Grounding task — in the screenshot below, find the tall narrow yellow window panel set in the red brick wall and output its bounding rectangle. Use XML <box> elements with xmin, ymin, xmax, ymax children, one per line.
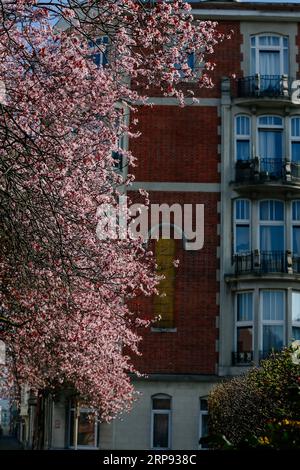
<box><xmin>154</xmin><ymin>238</ymin><xmax>176</xmax><ymax>329</ymax></box>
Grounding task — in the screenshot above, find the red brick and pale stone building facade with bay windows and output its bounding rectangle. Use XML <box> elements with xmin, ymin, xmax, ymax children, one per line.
<box><xmin>18</xmin><ymin>1</ymin><xmax>300</xmax><ymax>450</ymax></box>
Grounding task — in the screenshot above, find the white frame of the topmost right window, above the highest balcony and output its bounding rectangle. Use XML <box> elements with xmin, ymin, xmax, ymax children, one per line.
<box><xmin>250</xmin><ymin>33</ymin><xmax>290</xmax><ymax>75</ymax></box>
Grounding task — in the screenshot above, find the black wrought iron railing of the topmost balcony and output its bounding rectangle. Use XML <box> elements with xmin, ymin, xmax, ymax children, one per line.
<box><xmin>238</xmin><ymin>73</ymin><xmax>291</xmax><ymax>98</ymax></box>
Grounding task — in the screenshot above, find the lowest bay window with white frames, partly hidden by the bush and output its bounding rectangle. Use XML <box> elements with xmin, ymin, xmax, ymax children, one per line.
<box><xmin>232</xmin><ymin>287</ymin><xmax>300</xmax><ymax>366</ymax></box>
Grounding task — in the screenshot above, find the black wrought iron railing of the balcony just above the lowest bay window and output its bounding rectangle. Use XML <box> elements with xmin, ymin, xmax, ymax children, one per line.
<box><xmin>233</xmin><ymin>250</ymin><xmax>300</xmax><ymax>275</ymax></box>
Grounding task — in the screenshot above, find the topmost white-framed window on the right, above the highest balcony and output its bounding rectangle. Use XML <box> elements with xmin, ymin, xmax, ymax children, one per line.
<box><xmin>250</xmin><ymin>34</ymin><xmax>289</xmax><ymax>77</ymax></box>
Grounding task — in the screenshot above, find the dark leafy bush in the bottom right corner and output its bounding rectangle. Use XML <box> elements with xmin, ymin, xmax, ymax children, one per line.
<box><xmin>208</xmin><ymin>341</ymin><xmax>300</xmax><ymax>448</ymax></box>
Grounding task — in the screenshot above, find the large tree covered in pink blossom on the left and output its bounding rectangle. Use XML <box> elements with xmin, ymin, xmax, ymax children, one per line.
<box><xmin>0</xmin><ymin>0</ymin><xmax>223</xmax><ymax>419</ymax></box>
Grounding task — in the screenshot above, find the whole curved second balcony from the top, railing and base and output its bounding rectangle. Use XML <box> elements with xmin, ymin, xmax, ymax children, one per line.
<box><xmin>235</xmin><ymin>157</ymin><xmax>300</xmax><ymax>191</ymax></box>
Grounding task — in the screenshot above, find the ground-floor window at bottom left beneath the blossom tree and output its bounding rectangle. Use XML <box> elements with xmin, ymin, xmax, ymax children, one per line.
<box><xmin>69</xmin><ymin>404</ymin><xmax>98</xmax><ymax>448</ymax></box>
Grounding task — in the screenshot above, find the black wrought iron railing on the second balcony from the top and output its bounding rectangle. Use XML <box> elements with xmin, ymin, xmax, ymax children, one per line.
<box><xmin>235</xmin><ymin>157</ymin><xmax>300</xmax><ymax>184</ymax></box>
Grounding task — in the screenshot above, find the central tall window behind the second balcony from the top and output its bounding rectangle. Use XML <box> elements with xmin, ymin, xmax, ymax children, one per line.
<box><xmin>258</xmin><ymin>116</ymin><xmax>283</xmax><ymax>178</ymax></box>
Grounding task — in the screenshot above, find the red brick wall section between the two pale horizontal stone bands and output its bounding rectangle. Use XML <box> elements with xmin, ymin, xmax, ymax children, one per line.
<box><xmin>130</xmin><ymin>106</ymin><xmax>220</xmax><ymax>183</ymax></box>
